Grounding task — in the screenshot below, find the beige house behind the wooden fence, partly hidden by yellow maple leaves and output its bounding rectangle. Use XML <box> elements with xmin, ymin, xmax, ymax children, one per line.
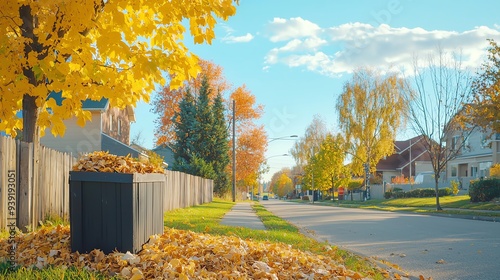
<box><xmin>40</xmin><ymin>93</ymin><xmax>140</xmax><ymax>157</ymax></box>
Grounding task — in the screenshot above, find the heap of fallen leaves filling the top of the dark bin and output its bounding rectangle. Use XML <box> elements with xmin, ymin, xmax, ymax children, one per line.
<box><xmin>73</xmin><ymin>151</ymin><xmax>165</xmax><ymax>174</ymax></box>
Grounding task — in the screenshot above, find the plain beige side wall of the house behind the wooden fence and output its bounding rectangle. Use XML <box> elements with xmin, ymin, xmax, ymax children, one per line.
<box><xmin>40</xmin><ymin>111</ymin><xmax>102</xmax><ymax>157</ymax></box>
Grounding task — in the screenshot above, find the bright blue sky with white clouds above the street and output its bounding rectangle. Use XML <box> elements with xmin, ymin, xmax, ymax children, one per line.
<box><xmin>131</xmin><ymin>0</ymin><xmax>500</xmax><ymax>179</ymax></box>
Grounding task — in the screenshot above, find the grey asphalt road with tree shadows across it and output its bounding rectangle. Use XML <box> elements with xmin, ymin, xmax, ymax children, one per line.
<box><xmin>261</xmin><ymin>199</ymin><xmax>500</xmax><ymax>280</ymax></box>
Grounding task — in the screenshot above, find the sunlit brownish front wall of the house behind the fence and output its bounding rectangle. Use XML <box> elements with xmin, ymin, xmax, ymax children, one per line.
<box><xmin>102</xmin><ymin>107</ymin><xmax>130</xmax><ymax>145</ymax></box>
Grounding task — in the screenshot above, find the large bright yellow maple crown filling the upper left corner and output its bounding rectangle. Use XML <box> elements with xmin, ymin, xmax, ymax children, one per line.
<box><xmin>0</xmin><ymin>0</ymin><xmax>238</xmax><ymax>142</ymax></box>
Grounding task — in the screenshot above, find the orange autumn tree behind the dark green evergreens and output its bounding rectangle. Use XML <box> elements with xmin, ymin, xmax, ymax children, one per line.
<box><xmin>153</xmin><ymin>59</ymin><xmax>267</xmax><ymax>190</ymax></box>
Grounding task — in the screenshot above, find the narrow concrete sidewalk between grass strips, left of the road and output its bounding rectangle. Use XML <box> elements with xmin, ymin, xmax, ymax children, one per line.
<box><xmin>220</xmin><ymin>202</ymin><xmax>266</xmax><ymax>230</ymax></box>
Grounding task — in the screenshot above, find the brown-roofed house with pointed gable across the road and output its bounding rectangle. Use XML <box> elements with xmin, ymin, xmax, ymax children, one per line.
<box><xmin>376</xmin><ymin>136</ymin><xmax>432</xmax><ymax>183</ymax></box>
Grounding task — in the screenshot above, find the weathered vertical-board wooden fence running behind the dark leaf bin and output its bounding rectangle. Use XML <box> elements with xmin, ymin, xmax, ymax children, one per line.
<box><xmin>0</xmin><ymin>136</ymin><xmax>213</xmax><ymax>230</ymax></box>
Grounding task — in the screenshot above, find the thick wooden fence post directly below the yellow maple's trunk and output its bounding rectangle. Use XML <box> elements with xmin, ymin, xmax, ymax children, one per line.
<box><xmin>16</xmin><ymin>141</ymin><xmax>33</xmax><ymax>231</ymax></box>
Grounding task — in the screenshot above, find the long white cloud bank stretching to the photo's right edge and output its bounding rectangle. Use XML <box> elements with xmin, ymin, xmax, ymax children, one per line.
<box><xmin>265</xmin><ymin>18</ymin><xmax>500</xmax><ymax>76</ymax></box>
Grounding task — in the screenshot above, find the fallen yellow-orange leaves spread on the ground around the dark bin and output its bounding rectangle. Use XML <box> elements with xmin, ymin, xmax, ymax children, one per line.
<box><xmin>0</xmin><ymin>226</ymin><xmax>372</xmax><ymax>279</ymax></box>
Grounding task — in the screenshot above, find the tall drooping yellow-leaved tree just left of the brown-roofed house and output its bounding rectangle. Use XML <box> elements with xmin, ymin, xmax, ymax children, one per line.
<box><xmin>337</xmin><ymin>69</ymin><xmax>406</xmax><ymax>199</ymax></box>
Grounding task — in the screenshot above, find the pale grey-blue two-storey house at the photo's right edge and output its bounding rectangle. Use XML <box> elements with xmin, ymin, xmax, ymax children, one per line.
<box><xmin>446</xmin><ymin>128</ymin><xmax>500</xmax><ymax>188</ymax></box>
